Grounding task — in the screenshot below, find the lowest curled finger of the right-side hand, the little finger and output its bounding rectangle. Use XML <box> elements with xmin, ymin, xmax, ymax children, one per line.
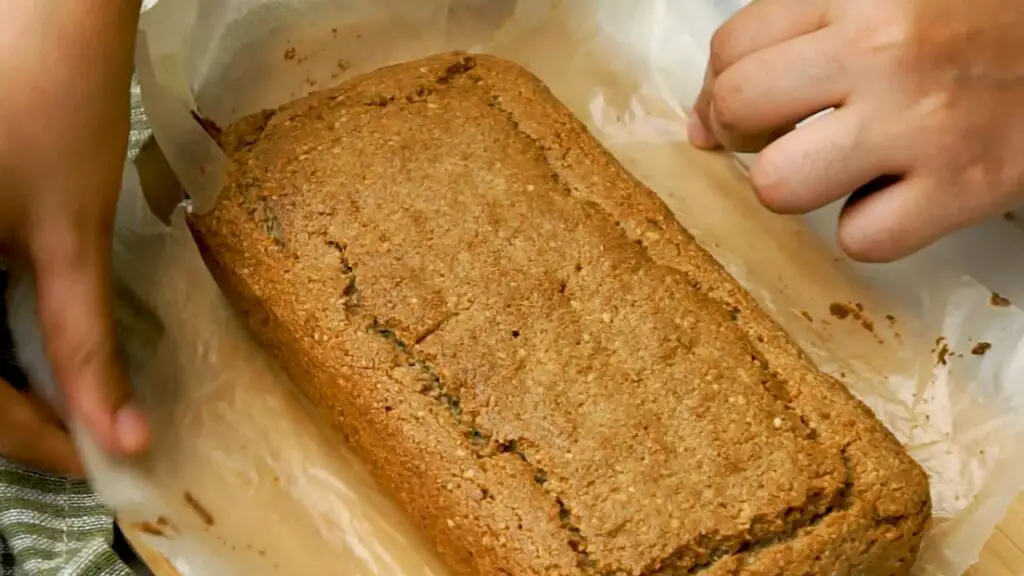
<box><xmin>839</xmin><ymin>177</ymin><xmax>998</xmax><ymax>262</ymax></box>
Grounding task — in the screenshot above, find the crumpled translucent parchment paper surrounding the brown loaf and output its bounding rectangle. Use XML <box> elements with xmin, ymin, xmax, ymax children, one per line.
<box><xmin>19</xmin><ymin>0</ymin><xmax>1024</xmax><ymax>576</ymax></box>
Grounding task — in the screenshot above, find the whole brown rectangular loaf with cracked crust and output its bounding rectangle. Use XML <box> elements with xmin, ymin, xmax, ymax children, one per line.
<box><xmin>191</xmin><ymin>53</ymin><xmax>930</xmax><ymax>576</ymax></box>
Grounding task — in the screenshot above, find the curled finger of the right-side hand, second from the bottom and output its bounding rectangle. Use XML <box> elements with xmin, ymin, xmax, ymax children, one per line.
<box><xmin>750</xmin><ymin>106</ymin><xmax>909</xmax><ymax>214</ymax></box>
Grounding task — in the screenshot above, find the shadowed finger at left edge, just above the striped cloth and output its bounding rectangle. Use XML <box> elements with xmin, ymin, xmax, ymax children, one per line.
<box><xmin>0</xmin><ymin>381</ymin><xmax>83</xmax><ymax>477</ymax></box>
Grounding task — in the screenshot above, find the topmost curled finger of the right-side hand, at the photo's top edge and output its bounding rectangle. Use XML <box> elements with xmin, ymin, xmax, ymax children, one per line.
<box><xmin>710</xmin><ymin>0</ymin><xmax>828</xmax><ymax>77</ymax></box>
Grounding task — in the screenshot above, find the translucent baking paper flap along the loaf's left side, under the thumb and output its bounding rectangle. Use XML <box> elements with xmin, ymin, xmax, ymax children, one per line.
<box><xmin>7</xmin><ymin>157</ymin><xmax>445</xmax><ymax>576</ymax></box>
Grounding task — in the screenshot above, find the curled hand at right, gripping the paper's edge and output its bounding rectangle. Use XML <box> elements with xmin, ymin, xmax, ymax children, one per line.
<box><xmin>689</xmin><ymin>0</ymin><xmax>1024</xmax><ymax>261</ymax></box>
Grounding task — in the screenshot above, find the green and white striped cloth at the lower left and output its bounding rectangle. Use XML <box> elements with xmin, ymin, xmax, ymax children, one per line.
<box><xmin>0</xmin><ymin>76</ymin><xmax>150</xmax><ymax>576</ymax></box>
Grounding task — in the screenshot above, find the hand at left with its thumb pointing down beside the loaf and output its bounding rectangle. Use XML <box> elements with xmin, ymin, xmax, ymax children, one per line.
<box><xmin>0</xmin><ymin>0</ymin><xmax>148</xmax><ymax>461</ymax></box>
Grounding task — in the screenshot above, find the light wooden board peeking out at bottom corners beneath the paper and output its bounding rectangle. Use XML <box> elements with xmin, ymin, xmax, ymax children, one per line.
<box><xmin>122</xmin><ymin>496</ymin><xmax>1024</xmax><ymax>576</ymax></box>
